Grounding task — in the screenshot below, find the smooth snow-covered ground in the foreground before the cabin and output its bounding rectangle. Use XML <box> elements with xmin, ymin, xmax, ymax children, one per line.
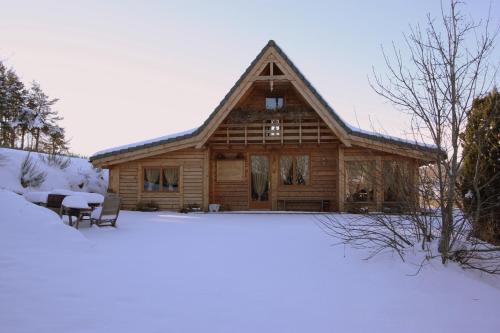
<box><xmin>0</xmin><ymin>191</ymin><xmax>500</xmax><ymax>333</ymax></box>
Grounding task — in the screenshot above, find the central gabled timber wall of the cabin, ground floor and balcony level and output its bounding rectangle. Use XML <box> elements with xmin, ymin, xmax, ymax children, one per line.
<box><xmin>208</xmin><ymin>82</ymin><xmax>339</xmax><ymax>211</ymax></box>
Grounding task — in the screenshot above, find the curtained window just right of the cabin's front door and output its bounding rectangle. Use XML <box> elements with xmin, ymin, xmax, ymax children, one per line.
<box><xmin>280</xmin><ymin>155</ymin><xmax>310</xmax><ymax>185</ymax></box>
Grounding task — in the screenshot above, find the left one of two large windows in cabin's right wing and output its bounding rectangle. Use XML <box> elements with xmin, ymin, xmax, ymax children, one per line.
<box><xmin>344</xmin><ymin>161</ymin><xmax>375</xmax><ymax>202</ymax></box>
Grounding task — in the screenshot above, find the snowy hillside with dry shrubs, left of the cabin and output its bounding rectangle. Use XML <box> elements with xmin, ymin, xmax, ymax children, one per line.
<box><xmin>0</xmin><ymin>148</ymin><xmax>108</xmax><ymax>193</ymax></box>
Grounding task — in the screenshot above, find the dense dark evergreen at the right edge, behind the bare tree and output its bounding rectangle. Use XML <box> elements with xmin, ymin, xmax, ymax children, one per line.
<box><xmin>462</xmin><ymin>89</ymin><xmax>500</xmax><ymax>243</ymax></box>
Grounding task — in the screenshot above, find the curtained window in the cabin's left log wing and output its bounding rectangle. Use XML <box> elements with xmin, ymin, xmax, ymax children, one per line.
<box><xmin>143</xmin><ymin>167</ymin><xmax>179</xmax><ymax>192</ymax></box>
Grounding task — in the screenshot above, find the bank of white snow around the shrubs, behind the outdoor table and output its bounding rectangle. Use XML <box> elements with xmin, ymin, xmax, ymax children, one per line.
<box><xmin>0</xmin><ymin>148</ymin><xmax>108</xmax><ymax>193</ymax></box>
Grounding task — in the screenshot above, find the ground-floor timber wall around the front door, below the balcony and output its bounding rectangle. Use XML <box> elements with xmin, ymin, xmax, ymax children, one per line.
<box><xmin>210</xmin><ymin>144</ymin><xmax>338</xmax><ymax>211</ymax></box>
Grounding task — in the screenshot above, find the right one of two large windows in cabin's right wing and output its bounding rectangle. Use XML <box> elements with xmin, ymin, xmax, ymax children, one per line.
<box><xmin>382</xmin><ymin>161</ymin><xmax>410</xmax><ymax>202</ymax></box>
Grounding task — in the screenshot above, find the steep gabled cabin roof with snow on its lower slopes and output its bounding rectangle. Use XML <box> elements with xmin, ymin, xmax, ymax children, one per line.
<box><xmin>90</xmin><ymin>40</ymin><xmax>437</xmax><ymax>161</ymax></box>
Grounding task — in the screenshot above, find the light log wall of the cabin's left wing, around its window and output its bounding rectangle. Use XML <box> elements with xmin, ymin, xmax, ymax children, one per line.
<box><xmin>113</xmin><ymin>149</ymin><xmax>208</xmax><ymax>210</ymax></box>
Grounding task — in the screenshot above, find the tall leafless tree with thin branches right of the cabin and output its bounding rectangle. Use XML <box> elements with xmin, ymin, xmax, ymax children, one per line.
<box><xmin>370</xmin><ymin>0</ymin><xmax>498</xmax><ymax>263</ymax></box>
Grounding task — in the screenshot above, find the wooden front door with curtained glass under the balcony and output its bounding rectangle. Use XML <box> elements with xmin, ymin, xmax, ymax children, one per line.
<box><xmin>248</xmin><ymin>154</ymin><xmax>272</xmax><ymax>209</ymax></box>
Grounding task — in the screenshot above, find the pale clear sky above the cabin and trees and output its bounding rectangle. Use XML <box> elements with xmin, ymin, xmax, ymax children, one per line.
<box><xmin>0</xmin><ymin>0</ymin><xmax>500</xmax><ymax>154</ymax></box>
